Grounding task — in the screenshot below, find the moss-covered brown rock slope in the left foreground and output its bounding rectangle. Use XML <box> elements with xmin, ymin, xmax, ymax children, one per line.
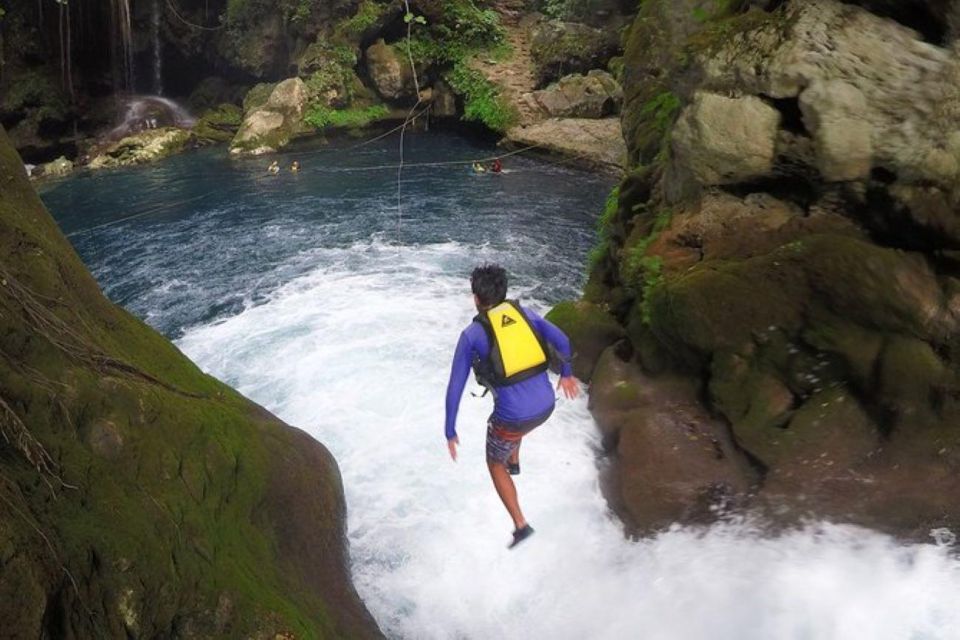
<box><xmin>0</xmin><ymin>129</ymin><xmax>380</xmax><ymax>638</ymax></box>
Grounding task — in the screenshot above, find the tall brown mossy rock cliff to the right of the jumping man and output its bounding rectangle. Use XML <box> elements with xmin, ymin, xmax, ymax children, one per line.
<box><xmin>567</xmin><ymin>0</ymin><xmax>960</xmax><ymax>537</ymax></box>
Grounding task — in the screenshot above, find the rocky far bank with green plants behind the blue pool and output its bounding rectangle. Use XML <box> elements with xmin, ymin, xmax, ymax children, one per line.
<box><xmin>0</xmin><ymin>0</ymin><xmax>628</xmax><ymax>176</ymax></box>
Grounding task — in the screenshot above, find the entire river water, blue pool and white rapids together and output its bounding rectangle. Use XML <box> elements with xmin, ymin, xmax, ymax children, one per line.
<box><xmin>43</xmin><ymin>134</ymin><xmax>960</xmax><ymax>640</ymax></box>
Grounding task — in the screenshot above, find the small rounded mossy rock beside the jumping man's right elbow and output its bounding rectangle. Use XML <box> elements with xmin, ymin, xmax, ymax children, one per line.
<box><xmin>546</xmin><ymin>301</ymin><xmax>625</xmax><ymax>382</ymax></box>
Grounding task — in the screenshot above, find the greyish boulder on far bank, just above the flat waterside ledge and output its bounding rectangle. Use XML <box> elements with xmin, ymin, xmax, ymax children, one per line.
<box><xmin>521</xmin><ymin>69</ymin><xmax>623</xmax><ymax>118</ymax></box>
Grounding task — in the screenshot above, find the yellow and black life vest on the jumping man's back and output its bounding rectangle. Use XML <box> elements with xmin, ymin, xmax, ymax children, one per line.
<box><xmin>474</xmin><ymin>300</ymin><xmax>549</xmax><ymax>387</ymax></box>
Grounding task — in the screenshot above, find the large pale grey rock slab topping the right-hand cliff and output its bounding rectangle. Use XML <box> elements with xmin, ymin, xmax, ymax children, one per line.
<box><xmin>694</xmin><ymin>0</ymin><xmax>960</xmax><ymax>238</ymax></box>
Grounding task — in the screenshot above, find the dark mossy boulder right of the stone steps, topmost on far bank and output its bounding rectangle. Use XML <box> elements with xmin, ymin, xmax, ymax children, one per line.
<box><xmin>530</xmin><ymin>20</ymin><xmax>620</xmax><ymax>86</ymax></box>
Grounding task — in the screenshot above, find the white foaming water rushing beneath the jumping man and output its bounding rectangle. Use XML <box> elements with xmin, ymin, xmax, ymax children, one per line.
<box><xmin>179</xmin><ymin>242</ymin><xmax>960</xmax><ymax>640</ymax></box>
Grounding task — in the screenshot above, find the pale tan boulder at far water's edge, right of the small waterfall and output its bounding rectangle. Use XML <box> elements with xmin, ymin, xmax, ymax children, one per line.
<box><xmin>230</xmin><ymin>78</ymin><xmax>307</xmax><ymax>155</ymax></box>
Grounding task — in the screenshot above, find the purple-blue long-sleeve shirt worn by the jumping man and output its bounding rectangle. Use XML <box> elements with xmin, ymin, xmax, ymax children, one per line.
<box><xmin>446</xmin><ymin>308</ymin><xmax>571</xmax><ymax>440</ymax></box>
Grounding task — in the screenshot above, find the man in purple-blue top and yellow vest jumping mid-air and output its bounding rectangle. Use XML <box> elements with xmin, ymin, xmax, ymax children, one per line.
<box><xmin>445</xmin><ymin>264</ymin><xmax>579</xmax><ymax>548</ymax></box>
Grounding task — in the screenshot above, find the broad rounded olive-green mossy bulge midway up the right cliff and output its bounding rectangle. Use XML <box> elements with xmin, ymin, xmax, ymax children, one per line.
<box><xmin>649</xmin><ymin>234</ymin><xmax>943</xmax><ymax>354</ymax></box>
